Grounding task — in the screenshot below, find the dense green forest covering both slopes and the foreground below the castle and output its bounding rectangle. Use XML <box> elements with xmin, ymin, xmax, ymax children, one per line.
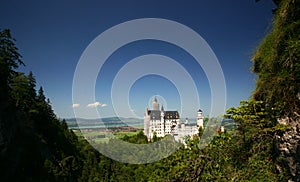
<box><xmin>0</xmin><ymin>0</ymin><xmax>300</xmax><ymax>181</ymax></box>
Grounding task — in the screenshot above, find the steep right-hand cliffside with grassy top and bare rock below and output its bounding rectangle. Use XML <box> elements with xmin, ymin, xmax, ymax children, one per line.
<box><xmin>253</xmin><ymin>0</ymin><xmax>300</xmax><ymax>180</ymax></box>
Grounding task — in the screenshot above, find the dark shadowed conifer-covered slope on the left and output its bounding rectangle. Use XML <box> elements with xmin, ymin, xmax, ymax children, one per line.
<box><xmin>0</xmin><ymin>29</ymin><xmax>99</xmax><ymax>181</ymax></box>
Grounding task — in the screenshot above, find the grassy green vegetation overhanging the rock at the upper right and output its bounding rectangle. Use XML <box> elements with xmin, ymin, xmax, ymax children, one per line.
<box><xmin>253</xmin><ymin>0</ymin><xmax>300</xmax><ymax>117</ymax></box>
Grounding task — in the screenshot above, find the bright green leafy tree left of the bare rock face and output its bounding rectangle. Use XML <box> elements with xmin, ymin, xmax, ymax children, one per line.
<box><xmin>225</xmin><ymin>100</ymin><xmax>288</xmax><ymax>181</ymax></box>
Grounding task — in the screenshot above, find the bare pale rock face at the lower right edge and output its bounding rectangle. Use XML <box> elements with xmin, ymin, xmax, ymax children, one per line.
<box><xmin>276</xmin><ymin>116</ymin><xmax>300</xmax><ymax>181</ymax></box>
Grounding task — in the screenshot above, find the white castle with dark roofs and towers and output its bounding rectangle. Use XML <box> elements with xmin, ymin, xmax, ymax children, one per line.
<box><xmin>144</xmin><ymin>97</ymin><xmax>203</xmax><ymax>141</ymax></box>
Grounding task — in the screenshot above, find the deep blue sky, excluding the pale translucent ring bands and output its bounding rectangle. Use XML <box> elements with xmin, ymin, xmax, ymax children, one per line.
<box><xmin>0</xmin><ymin>0</ymin><xmax>274</xmax><ymax>118</ymax></box>
